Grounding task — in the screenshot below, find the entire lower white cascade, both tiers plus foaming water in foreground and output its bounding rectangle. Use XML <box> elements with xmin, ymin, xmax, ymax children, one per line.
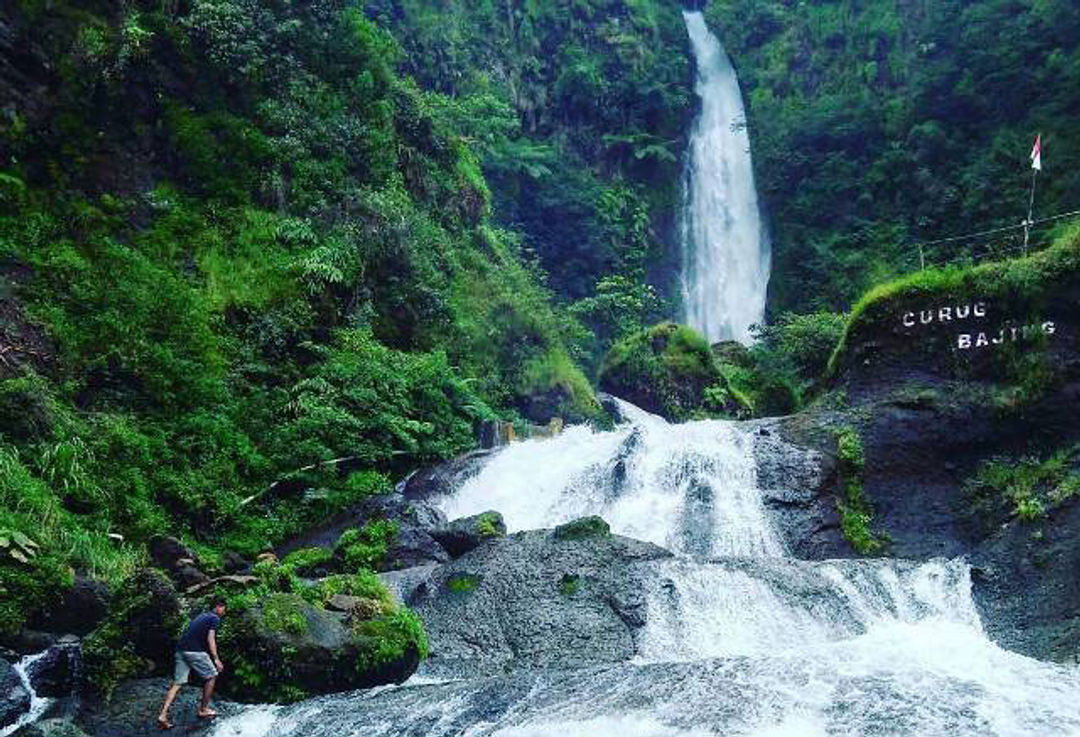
<box><xmin>214</xmin><ymin>403</ymin><xmax>1080</xmax><ymax>737</ymax></box>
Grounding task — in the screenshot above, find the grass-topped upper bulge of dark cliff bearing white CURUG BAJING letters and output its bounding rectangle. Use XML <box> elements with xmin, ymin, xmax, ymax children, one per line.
<box><xmin>828</xmin><ymin>228</ymin><xmax>1080</xmax><ymax>400</ymax></box>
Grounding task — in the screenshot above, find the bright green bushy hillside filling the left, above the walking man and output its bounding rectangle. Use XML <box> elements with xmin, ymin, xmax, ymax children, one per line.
<box><xmin>0</xmin><ymin>0</ymin><xmax>600</xmax><ymax>600</ymax></box>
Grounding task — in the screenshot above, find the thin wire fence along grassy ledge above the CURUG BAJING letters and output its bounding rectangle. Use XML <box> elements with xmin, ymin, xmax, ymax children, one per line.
<box><xmin>903</xmin><ymin>210</ymin><xmax>1080</xmax><ymax>270</ymax></box>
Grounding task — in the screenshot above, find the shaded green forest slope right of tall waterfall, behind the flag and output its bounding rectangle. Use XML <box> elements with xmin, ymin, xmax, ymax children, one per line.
<box><xmin>706</xmin><ymin>0</ymin><xmax>1080</xmax><ymax>312</ymax></box>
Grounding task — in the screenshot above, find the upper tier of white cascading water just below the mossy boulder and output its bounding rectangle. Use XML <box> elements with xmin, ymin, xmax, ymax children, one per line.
<box><xmin>443</xmin><ymin>402</ymin><xmax>783</xmax><ymax>555</ymax></box>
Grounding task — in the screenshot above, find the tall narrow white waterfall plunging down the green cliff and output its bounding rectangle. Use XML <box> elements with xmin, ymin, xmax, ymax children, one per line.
<box><xmin>680</xmin><ymin>11</ymin><xmax>770</xmax><ymax>343</ymax></box>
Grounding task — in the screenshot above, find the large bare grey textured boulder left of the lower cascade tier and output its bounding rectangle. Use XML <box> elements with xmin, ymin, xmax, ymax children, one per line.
<box><xmin>401</xmin><ymin>531</ymin><xmax>671</xmax><ymax>675</ymax></box>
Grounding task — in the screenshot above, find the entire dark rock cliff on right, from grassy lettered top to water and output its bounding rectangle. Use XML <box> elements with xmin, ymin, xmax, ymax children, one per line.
<box><xmin>779</xmin><ymin>239</ymin><xmax>1080</xmax><ymax>660</ymax></box>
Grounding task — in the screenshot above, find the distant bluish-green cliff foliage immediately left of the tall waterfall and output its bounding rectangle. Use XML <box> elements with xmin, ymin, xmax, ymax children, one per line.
<box><xmin>367</xmin><ymin>0</ymin><xmax>692</xmax><ymax>309</ymax></box>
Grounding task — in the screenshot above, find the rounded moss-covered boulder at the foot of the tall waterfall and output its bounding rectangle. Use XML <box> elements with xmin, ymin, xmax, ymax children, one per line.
<box><xmin>599</xmin><ymin>322</ymin><xmax>737</xmax><ymax>421</ymax></box>
